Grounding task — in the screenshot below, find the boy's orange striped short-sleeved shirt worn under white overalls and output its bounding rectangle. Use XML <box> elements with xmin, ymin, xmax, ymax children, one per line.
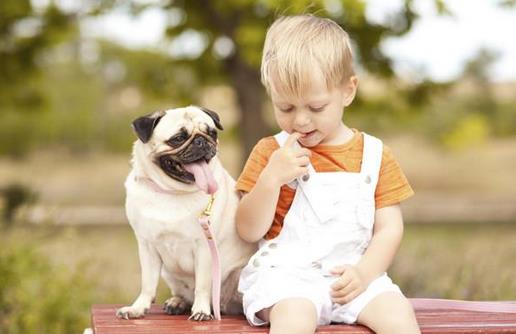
<box><xmin>236</xmin><ymin>129</ymin><xmax>414</xmax><ymax>239</ymax></box>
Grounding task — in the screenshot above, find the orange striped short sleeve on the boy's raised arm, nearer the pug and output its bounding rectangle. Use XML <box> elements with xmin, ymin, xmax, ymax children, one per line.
<box><xmin>236</xmin><ymin>137</ymin><xmax>279</xmax><ymax>193</ymax></box>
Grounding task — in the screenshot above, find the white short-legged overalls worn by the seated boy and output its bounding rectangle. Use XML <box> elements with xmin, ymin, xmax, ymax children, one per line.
<box><xmin>238</xmin><ymin>132</ymin><xmax>401</xmax><ymax>325</ymax></box>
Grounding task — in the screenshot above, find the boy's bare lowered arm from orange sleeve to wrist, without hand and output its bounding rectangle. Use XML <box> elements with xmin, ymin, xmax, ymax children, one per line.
<box><xmin>357</xmin><ymin>204</ymin><xmax>403</xmax><ymax>284</ymax></box>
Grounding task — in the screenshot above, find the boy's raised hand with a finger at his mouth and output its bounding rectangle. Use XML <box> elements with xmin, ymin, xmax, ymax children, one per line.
<box><xmin>262</xmin><ymin>132</ymin><xmax>312</xmax><ymax>186</ymax></box>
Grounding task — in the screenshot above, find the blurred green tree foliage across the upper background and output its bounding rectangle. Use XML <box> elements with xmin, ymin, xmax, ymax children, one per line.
<box><xmin>0</xmin><ymin>0</ymin><xmax>516</xmax><ymax>158</ymax></box>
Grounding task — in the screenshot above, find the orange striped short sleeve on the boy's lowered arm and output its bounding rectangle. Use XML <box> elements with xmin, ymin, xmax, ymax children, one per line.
<box><xmin>375</xmin><ymin>145</ymin><xmax>414</xmax><ymax>209</ymax></box>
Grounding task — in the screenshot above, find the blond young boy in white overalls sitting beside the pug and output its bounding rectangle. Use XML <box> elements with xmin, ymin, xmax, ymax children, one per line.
<box><xmin>236</xmin><ymin>15</ymin><xmax>419</xmax><ymax>334</ymax></box>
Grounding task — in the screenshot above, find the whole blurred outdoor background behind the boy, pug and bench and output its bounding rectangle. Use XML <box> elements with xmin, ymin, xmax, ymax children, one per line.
<box><xmin>0</xmin><ymin>0</ymin><xmax>516</xmax><ymax>333</ymax></box>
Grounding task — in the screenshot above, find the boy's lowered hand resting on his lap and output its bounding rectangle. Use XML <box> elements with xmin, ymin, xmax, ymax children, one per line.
<box><xmin>330</xmin><ymin>265</ymin><xmax>367</xmax><ymax>305</ymax></box>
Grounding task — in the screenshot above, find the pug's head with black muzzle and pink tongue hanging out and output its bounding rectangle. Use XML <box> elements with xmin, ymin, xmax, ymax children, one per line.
<box><xmin>133</xmin><ymin>106</ymin><xmax>223</xmax><ymax>194</ymax></box>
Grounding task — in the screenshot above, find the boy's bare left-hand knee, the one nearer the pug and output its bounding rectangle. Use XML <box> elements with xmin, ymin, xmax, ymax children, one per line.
<box><xmin>270</xmin><ymin>298</ymin><xmax>317</xmax><ymax>334</ymax></box>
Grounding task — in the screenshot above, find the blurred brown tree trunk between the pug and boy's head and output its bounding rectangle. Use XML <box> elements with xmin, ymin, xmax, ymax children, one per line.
<box><xmin>226</xmin><ymin>56</ymin><xmax>269</xmax><ymax>167</ymax></box>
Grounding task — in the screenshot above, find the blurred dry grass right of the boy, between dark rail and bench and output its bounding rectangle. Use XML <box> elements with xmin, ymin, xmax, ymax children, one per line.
<box><xmin>390</xmin><ymin>222</ymin><xmax>516</xmax><ymax>300</ymax></box>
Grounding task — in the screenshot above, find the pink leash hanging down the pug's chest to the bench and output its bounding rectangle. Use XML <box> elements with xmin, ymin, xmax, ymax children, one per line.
<box><xmin>199</xmin><ymin>195</ymin><xmax>221</xmax><ymax>320</ymax></box>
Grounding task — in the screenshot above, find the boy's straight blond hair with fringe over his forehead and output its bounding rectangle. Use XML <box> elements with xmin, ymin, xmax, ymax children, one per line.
<box><xmin>261</xmin><ymin>15</ymin><xmax>354</xmax><ymax>96</ymax></box>
